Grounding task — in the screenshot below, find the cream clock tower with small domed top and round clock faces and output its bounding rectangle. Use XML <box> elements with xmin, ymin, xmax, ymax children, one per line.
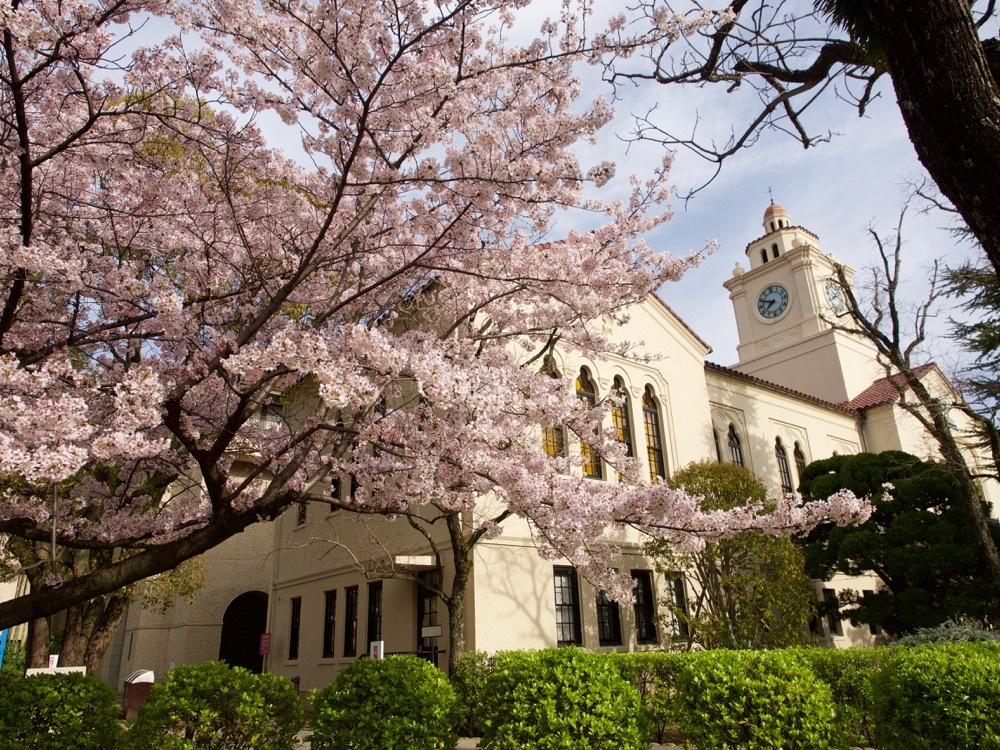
<box><xmin>724</xmin><ymin>203</ymin><xmax>884</xmax><ymax>403</ymax></box>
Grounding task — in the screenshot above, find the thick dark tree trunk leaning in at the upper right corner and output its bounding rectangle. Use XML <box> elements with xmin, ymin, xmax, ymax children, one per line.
<box><xmin>863</xmin><ymin>0</ymin><xmax>1000</xmax><ymax>278</ymax></box>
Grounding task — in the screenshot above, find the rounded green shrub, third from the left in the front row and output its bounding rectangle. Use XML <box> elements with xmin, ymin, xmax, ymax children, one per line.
<box><xmin>310</xmin><ymin>656</ymin><xmax>460</xmax><ymax>750</ymax></box>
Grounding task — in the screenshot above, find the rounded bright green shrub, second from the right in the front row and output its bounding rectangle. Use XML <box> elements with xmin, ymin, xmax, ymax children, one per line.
<box><xmin>677</xmin><ymin>651</ymin><xmax>846</xmax><ymax>750</ymax></box>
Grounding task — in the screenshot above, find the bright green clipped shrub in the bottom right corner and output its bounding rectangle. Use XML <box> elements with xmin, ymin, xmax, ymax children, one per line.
<box><xmin>874</xmin><ymin>643</ymin><xmax>1000</xmax><ymax>750</ymax></box>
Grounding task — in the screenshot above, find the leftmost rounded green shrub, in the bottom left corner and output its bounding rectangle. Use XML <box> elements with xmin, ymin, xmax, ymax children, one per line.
<box><xmin>0</xmin><ymin>673</ymin><xmax>122</xmax><ymax>750</ymax></box>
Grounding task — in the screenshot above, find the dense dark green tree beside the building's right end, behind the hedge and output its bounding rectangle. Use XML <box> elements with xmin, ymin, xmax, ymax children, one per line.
<box><xmin>800</xmin><ymin>451</ymin><xmax>1000</xmax><ymax>635</ymax></box>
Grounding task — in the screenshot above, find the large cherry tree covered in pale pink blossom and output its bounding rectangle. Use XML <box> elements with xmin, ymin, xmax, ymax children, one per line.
<box><xmin>0</xmin><ymin>0</ymin><xmax>866</xmax><ymax>640</ymax></box>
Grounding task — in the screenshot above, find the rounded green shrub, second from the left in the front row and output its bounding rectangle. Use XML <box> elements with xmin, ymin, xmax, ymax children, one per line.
<box><xmin>128</xmin><ymin>662</ymin><xmax>303</xmax><ymax>750</ymax></box>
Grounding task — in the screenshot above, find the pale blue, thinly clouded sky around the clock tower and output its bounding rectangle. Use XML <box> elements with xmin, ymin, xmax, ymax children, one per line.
<box><xmin>584</xmin><ymin>20</ymin><xmax>972</xmax><ymax>371</ymax></box>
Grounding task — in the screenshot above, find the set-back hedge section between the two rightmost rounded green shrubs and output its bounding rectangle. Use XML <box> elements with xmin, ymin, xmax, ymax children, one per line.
<box><xmin>793</xmin><ymin>648</ymin><xmax>885</xmax><ymax>747</ymax></box>
